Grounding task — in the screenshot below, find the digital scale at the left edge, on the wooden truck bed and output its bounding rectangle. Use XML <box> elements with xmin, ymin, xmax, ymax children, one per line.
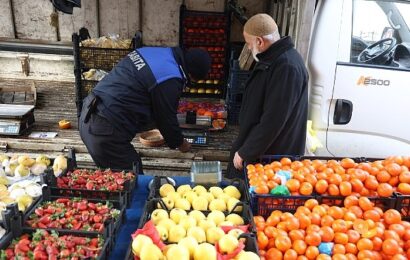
<box><xmin>0</xmin><ymin>104</ymin><xmax>35</xmax><ymax>135</ymax></box>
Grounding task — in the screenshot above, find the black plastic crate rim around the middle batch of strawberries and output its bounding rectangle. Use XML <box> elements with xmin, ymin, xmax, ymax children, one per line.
<box><xmin>21</xmin><ymin>187</ymin><xmax>125</xmax><ymax>239</ymax></box>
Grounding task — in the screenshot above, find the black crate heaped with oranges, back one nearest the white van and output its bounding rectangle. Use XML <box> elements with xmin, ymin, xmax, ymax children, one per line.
<box><xmin>246</xmin><ymin>156</ymin><xmax>410</xmax><ymax>218</ymax></box>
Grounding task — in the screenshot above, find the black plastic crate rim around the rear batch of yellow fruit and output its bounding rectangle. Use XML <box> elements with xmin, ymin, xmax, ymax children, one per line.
<box><xmin>148</xmin><ymin>176</ymin><xmax>250</xmax><ymax>204</ymax></box>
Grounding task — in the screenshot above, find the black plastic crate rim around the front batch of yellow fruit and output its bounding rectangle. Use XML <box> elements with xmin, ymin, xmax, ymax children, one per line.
<box><xmin>138</xmin><ymin>198</ymin><xmax>256</xmax><ymax>233</ymax></box>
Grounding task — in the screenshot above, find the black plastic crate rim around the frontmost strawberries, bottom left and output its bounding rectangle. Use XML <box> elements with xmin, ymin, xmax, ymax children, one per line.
<box><xmin>0</xmin><ymin>226</ymin><xmax>112</xmax><ymax>260</ymax></box>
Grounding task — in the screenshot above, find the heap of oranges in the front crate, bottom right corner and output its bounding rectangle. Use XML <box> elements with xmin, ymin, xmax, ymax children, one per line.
<box><xmin>254</xmin><ymin>195</ymin><xmax>410</xmax><ymax>260</ymax></box>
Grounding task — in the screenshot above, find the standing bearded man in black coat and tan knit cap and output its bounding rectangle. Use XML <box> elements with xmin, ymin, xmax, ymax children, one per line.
<box><xmin>231</xmin><ymin>14</ymin><xmax>308</xmax><ymax>173</ymax></box>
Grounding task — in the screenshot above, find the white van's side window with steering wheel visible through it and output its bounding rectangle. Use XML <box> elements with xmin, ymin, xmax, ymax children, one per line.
<box><xmin>350</xmin><ymin>0</ymin><xmax>410</xmax><ymax>69</ymax></box>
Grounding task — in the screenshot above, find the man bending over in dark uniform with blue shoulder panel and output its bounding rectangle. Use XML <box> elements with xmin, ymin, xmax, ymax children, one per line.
<box><xmin>79</xmin><ymin>47</ymin><xmax>211</xmax><ymax>173</ymax></box>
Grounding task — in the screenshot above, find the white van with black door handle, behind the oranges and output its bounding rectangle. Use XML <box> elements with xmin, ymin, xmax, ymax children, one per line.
<box><xmin>307</xmin><ymin>0</ymin><xmax>410</xmax><ymax>157</ymax></box>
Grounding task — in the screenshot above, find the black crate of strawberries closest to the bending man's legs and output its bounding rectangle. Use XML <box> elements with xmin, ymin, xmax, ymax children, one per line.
<box><xmin>41</xmin><ymin>150</ymin><xmax>139</xmax><ymax>206</ymax></box>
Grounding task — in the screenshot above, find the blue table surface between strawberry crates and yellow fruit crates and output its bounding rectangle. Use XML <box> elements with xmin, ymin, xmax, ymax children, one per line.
<box><xmin>110</xmin><ymin>175</ymin><xmax>190</xmax><ymax>260</ymax></box>
